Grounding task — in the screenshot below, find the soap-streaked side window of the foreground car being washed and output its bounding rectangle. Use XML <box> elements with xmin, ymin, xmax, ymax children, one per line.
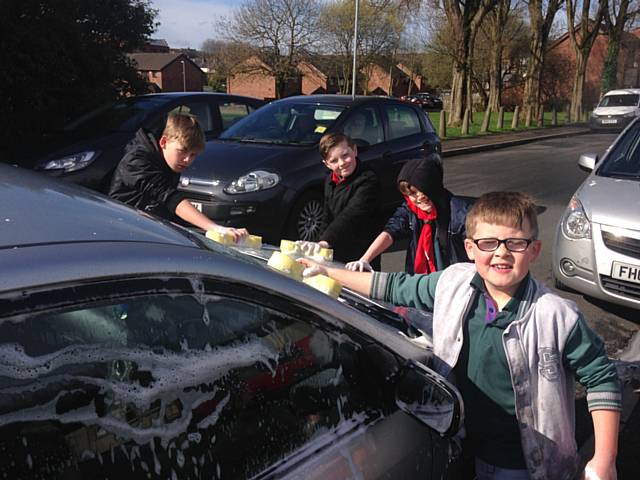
<box><xmin>0</xmin><ymin>281</ymin><xmax>382</xmax><ymax>478</ymax></box>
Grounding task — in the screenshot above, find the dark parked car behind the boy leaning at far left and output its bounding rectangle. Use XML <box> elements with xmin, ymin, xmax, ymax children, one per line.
<box><xmin>30</xmin><ymin>92</ymin><xmax>264</xmax><ymax>193</ymax></box>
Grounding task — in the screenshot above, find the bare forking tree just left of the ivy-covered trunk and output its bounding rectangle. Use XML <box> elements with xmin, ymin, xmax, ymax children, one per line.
<box><xmin>566</xmin><ymin>0</ymin><xmax>608</xmax><ymax>121</ymax></box>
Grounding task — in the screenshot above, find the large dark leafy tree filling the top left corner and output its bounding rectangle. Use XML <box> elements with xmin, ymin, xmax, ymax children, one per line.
<box><xmin>0</xmin><ymin>0</ymin><xmax>157</xmax><ymax>156</ymax></box>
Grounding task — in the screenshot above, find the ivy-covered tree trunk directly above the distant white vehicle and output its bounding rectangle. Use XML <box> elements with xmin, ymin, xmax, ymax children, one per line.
<box><xmin>600</xmin><ymin>0</ymin><xmax>638</xmax><ymax>94</ymax></box>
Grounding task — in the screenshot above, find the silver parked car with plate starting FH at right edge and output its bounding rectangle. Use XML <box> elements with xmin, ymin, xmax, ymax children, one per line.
<box><xmin>553</xmin><ymin>119</ymin><xmax>640</xmax><ymax>309</ymax></box>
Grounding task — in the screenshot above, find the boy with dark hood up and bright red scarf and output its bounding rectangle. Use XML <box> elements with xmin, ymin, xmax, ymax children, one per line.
<box><xmin>346</xmin><ymin>154</ymin><xmax>471</xmax><ymax>273</ymax></box>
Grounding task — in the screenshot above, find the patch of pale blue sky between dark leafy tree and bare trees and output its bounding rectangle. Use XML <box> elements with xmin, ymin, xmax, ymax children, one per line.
<box><xmin>151</xmin><ymin>0</ymin><xmax>241</xmax><ymax>49</ymax></box>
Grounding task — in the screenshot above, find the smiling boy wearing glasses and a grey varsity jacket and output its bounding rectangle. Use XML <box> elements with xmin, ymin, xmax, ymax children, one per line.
<box><xmin>300</xmin><ymin>192</ymin><xmax>621</xmax><ymax>480</ymax></box>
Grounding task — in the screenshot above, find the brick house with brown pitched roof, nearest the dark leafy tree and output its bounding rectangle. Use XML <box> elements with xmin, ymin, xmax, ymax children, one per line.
<box><xmin>129</xmin><ymin>52</ymin><xmax>205</xmax><ymax>92</ymax></box>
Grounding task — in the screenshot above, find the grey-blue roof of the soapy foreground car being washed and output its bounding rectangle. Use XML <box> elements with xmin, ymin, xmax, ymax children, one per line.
<box><xmin>0</xmin><ymin>164</ymin><xmax>195</xmax><ymax>250</ymax></box>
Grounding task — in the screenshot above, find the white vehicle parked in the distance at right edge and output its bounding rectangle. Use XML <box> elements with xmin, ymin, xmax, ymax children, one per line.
<box><xmin>589</xmin><ymin>88</ymin><xmax>640</xmax><ymax>130</ymax></box>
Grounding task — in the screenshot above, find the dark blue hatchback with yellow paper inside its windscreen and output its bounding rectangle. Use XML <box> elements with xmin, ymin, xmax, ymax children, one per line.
<box><xmin>181</xmin><ymin>95</ymin><xmax>441</xmax><ymax>242</ymax></box>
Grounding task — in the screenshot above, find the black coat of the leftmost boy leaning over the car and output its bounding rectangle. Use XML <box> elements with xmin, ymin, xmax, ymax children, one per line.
<box><xmin>109</xmin><ymin>129</ymin><xmax>184</xmax><ymax>221</ymax></box>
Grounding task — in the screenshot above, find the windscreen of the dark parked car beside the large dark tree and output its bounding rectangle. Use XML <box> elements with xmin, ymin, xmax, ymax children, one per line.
<box><xmin>64</xmin><ymin>97</ymin><xmax>170</xmax><ymax>134</ymax></box>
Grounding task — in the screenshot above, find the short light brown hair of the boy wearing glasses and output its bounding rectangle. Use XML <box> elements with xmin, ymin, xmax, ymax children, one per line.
<box><xmin>465</xmin><ymin>192</ymin><xmax>538</xmax><ymax>238</ymax></box>
